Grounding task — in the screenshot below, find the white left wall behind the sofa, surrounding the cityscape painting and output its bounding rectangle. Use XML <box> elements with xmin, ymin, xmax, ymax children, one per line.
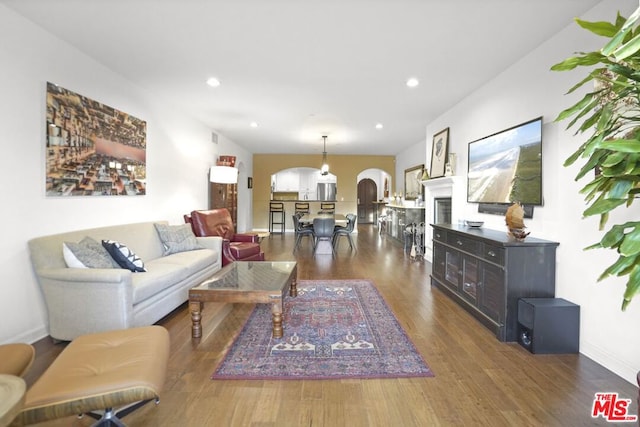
<box><xmin>0</xmin><ymin>5</ymin><xmax>253</xmax><ymax>343</ymax></box>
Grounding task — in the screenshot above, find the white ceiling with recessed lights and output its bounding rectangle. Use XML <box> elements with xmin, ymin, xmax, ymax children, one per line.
<box><xmin>0</xmin><ymin>0</ymin><xmax>613</xmax><ymax>155</ymax></box>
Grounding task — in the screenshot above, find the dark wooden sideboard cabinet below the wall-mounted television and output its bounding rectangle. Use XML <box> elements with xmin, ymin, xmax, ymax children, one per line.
<box><xmin>431</xmin><ymin>224</ymin><xmax>558</xmax><ymax>341</ymax></box>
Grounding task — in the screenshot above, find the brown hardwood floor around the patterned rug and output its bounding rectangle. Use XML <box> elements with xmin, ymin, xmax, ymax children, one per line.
<box><xmin>22</xmin><ymin>224</ymin><xmax>638</xmax><ymax>427</ymax></box>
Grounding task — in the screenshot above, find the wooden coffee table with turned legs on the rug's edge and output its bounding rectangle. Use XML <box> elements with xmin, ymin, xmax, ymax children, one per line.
<box><xmin>189</xmin><ymin>261</ymin><xmax>298</xmax><ymax>338</ymax></box>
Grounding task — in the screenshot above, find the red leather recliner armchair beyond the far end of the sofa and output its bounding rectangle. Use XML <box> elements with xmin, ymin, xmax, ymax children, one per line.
<box><xmin>184</xmin><ymin>208</ymin><xmax>264</xmax><ymax>266</ymax></box>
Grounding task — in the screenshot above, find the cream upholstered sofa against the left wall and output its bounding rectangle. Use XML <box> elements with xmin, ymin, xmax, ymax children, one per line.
<box><xmin>29</xmin><ymin>221</ymin><xmax>222</xmax><ymax>341</ymax></box>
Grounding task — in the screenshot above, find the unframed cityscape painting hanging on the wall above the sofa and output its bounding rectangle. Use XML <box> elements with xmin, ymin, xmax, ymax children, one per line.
<box><xmin>46</xmin><ymin>82</ymin><xmax>147</xmax><ymax>196</ymax></box>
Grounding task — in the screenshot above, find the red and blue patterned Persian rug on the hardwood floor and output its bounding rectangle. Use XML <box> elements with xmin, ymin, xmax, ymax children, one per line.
<box><xmin>211</xmin><ymin>280</ymin><xmax>433</xmax><ymax>380</ymax></box>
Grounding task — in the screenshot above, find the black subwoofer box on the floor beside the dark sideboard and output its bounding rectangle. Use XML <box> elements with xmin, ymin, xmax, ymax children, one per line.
<box><xmin>518</xmin><ymin>298</ymin><xmax>580</xmax><ymax>354</ymax></box>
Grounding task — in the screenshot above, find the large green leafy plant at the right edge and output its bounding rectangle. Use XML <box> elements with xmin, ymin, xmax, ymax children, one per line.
<box><xmin>551</xmin><ymin>8</ymin><xmax>640</xmax><ymax>310</ymax></box>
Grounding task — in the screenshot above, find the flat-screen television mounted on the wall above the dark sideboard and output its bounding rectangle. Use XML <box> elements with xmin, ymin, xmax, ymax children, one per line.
<box><xmin>467</xmin><ymin>117</ymin><xmax>542</xmax><ymax>213</ymax></box>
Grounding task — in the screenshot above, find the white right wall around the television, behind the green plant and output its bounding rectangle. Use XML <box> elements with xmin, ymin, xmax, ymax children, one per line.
<box><xmin>426</xmin><ymin>0</ymin><xmax>640</xmax><ymax>383</ymax></box>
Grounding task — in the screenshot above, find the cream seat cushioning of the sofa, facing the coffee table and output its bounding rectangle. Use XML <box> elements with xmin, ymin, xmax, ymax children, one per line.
<box><xmin>131</xmin><ymin>249</ymin><xmax>218</xmax><ymax>305</ymax></box>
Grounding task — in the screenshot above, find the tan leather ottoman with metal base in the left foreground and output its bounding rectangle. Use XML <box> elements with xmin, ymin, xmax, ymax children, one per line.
<box><xmin>14</xmin><ymin>326</ymin><xmax>169</xmax><ymax>425</ymax></box>
